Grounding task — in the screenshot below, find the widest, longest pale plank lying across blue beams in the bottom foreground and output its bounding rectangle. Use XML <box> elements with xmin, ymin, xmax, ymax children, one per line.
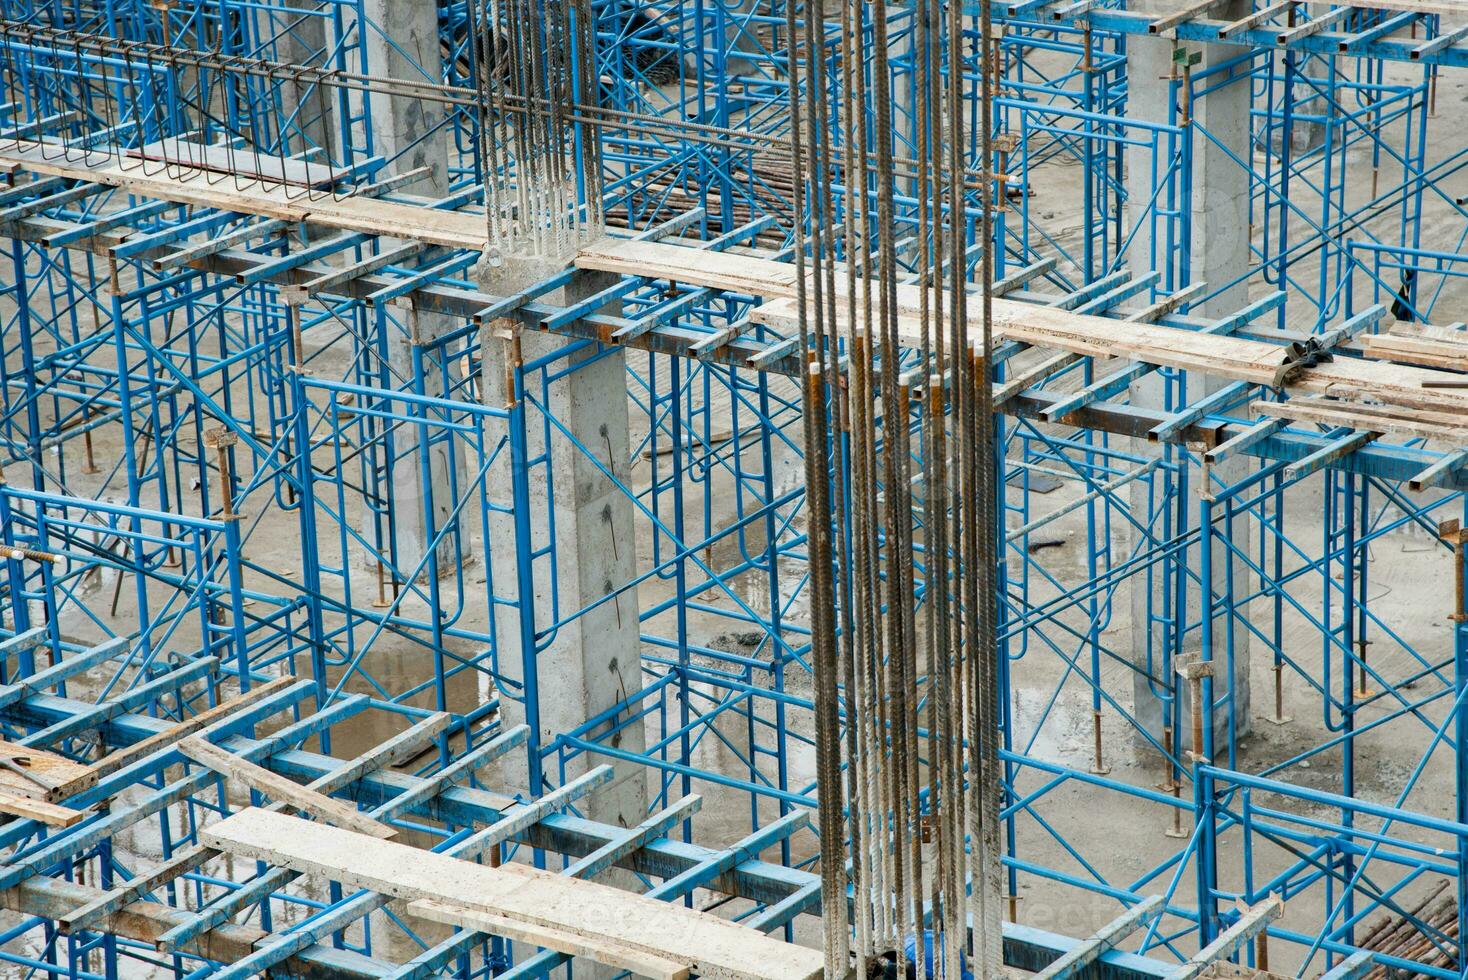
<box><xmin>201</xmin><ymin>808</ymin><xmax>825</xmax><ymax>980</ymax></box>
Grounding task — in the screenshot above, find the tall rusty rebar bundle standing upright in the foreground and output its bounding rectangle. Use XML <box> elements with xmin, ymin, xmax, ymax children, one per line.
<box><xmin>787</xmin><ymin>0</ymin><xmax>1003</xmax><ymax>977</ymax></box>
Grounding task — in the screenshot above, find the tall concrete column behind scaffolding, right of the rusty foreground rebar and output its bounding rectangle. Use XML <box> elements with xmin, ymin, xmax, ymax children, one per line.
<box><xmin>1126</xmin><ymin>0</ymin><xmax>1252</xmax><ymax>751</ymax></box>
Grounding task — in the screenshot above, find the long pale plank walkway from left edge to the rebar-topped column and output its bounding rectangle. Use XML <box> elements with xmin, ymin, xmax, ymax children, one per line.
<box><xmin>0</xmin><ymin>141</ymin><xmax>486</xmax><ymax>251</ymax></box>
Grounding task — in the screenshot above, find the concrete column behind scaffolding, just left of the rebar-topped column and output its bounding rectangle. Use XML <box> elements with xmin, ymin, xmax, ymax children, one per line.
<box><xmin>363</xmin><ymin>0</ymin><xmax>458</xmax><ymax>575</ymax></box>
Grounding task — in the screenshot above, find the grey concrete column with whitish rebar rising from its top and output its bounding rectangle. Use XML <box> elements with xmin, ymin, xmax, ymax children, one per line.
<box><xmin>480</xmin><ymin>258</ymin><xmax>647</xmax><ymax>839</ymax></box>
